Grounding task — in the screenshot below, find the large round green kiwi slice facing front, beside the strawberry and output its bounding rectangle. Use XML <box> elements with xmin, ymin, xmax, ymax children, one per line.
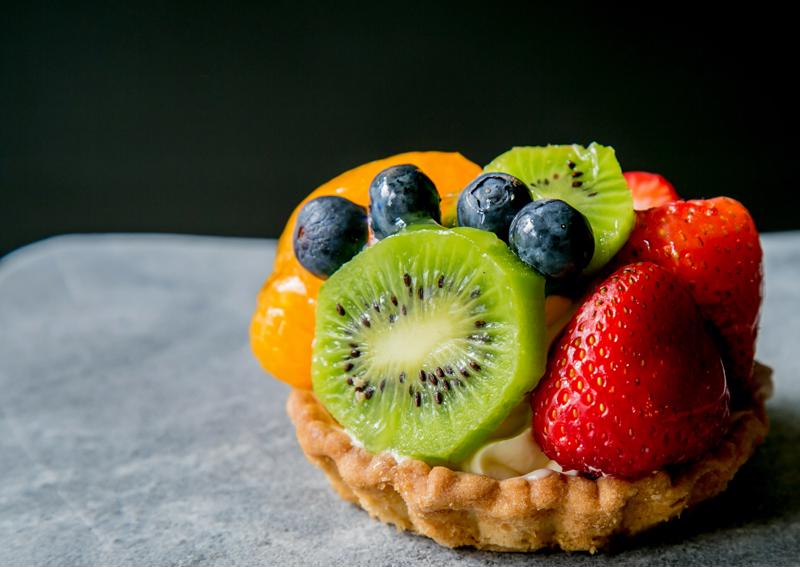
<box><xmin>311</xmin><ymin>226</ymin><xmax>546</xmax><ymax>464</ymax></box>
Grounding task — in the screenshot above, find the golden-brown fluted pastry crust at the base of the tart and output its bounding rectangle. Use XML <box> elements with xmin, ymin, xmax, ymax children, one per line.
<box><xmin>287</xmin><ymin>364</ymin><xmax>772</xmax><ymax>552</ymax></box>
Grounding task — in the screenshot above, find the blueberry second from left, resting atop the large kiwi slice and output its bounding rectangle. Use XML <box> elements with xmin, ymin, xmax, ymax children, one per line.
<box><xmin>369</xmin><ymin>165</ymin><xmax>442</xmax><ymax>240</ymax></box>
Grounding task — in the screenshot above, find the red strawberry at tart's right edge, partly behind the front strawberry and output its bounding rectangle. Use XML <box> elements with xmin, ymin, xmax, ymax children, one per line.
<box><xmin>618</xmin><ymin>197</ymin><xmax>763</xmax><ymax>391</ymax></box>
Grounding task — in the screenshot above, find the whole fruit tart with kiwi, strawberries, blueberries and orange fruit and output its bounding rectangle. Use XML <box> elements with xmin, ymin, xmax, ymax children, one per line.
<box><xmin>250</xmin><ymin>144</ymin><xmax>771</xmax><ymax>552</ymax></box>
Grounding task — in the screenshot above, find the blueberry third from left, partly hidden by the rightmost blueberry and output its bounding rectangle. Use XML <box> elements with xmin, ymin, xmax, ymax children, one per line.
<box><xmin>457</xmin><ymin>173</ymin><xmax>531</xmax><ymax>242</ymax></box>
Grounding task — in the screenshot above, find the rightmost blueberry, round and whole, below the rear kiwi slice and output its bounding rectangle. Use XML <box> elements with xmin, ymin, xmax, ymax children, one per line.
<box><xmin>508</xmin><ymin>199</ymin><xmax>594</xmax><ymax>279</ymax></box>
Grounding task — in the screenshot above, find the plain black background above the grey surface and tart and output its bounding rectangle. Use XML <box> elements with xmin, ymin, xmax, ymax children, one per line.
<box><xmin>0</xmin><ymin>2</ymin><xmax>800</xmax><ymax>254</ymax></box>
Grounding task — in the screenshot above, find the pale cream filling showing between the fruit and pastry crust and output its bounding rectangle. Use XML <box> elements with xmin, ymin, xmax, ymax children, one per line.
<box><xmin>344</xmin><ymin>295</ymin><xmax>577</xmax><ymax>480</ymax></box>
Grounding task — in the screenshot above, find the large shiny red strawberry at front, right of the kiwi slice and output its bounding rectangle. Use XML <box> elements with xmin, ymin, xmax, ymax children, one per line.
<box><xmin>531</xmin><ymin>262</ymin><xmax>729</xmax><ymax>478</ymax></box>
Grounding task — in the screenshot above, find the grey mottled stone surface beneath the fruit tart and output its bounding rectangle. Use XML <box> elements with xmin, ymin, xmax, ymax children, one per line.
<box><xmin>0</xmin><ymin>233</ymin><xmax>800</xmax><ymax>566</ymax></box>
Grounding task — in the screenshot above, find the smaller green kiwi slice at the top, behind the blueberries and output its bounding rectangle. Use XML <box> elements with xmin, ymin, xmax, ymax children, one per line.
<box><xmin>485</xmin><ymin>143</ymin><xmax>635</xmax><ymax>273</ymax></box>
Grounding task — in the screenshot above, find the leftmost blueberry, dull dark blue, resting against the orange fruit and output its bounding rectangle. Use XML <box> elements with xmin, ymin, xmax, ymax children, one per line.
<box><xmin>294</xmin><ymin>197</ymin><xmax>368</xmax><ymax>279</ymax></box>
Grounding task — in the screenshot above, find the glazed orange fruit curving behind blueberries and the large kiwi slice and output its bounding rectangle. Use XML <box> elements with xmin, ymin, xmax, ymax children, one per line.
<box><xmin>250</xmin><ymin>152</ymin><xmax>481</xmax><ymax>388</ymax></box>
